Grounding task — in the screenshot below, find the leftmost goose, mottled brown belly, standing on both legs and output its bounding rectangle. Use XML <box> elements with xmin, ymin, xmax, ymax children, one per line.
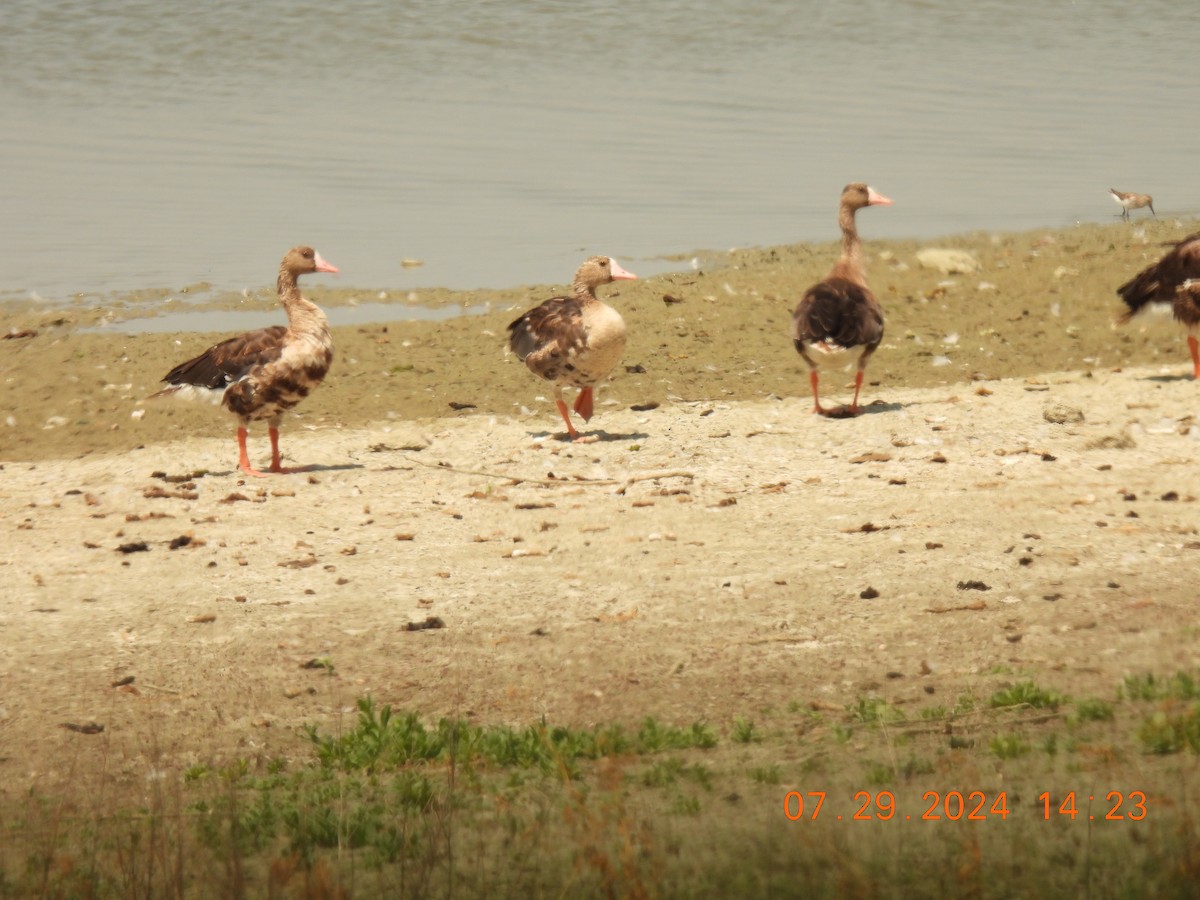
<box><xmin>154</xmin><ymin>247</ymin><xmax>337</xmax><ymax>476</ymax></box>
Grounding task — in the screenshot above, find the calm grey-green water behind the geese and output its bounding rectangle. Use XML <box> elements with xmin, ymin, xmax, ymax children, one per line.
<box><xmin>0</xmin><ymin>0</ymin><xmax>1200</xmax><ymax>299</ymax></box>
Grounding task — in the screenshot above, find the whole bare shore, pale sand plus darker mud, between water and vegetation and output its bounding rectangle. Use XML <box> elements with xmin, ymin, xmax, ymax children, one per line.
<box><xmin>0</xmin><ymin>222</ymin><xmax>1200</xmax><ymax>900</ymax></box>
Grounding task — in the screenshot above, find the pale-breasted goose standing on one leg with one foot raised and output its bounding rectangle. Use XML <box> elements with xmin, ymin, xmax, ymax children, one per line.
<box><xmin>509</xmin><ymin>257</ymin><xmax>637</xmax><ymax>440</ymax></box>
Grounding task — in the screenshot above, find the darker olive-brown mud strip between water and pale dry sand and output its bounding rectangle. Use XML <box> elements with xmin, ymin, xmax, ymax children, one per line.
<box><xmin>0</xmin><ymin>215</ymin><xmax>1200</xmax><ymax>460</ymax></box>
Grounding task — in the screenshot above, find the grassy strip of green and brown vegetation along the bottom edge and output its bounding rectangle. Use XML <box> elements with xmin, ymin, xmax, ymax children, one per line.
<box><xmin>0</xmin><ymin>674</ymin><xmax>1200</xmax><ymax>899</ymax></box>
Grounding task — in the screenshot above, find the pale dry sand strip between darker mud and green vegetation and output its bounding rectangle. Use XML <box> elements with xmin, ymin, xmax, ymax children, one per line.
<box><xmin>0</xmin><ymin>355</ymin><xmax>1200</xmax><ymax>772</ymax></box>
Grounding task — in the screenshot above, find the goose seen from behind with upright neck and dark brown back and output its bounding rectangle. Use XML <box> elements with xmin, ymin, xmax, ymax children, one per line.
<box><xmin>792</xmin><ymin>182</ymin><xmax>892</xmax><ymax>416</ymax></box>
